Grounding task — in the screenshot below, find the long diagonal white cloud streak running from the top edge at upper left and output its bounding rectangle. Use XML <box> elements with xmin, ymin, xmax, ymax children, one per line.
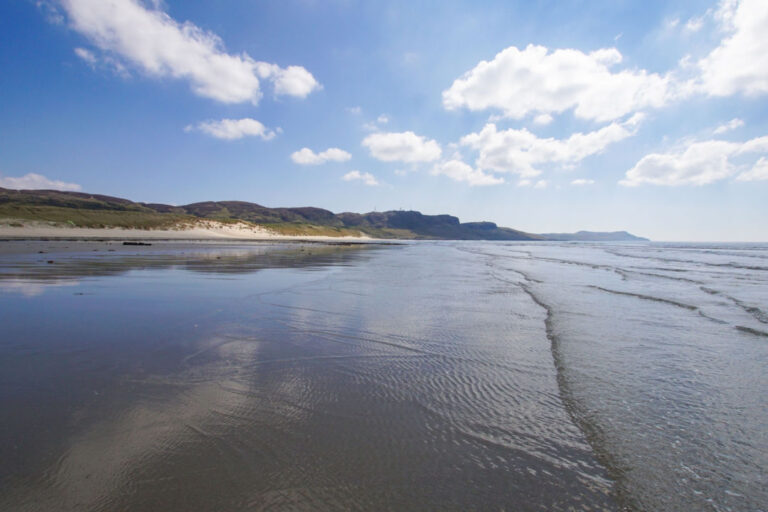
<box><xmin>60</xmin><ymin>0</ymin><xmax>319</xmax><ymax>104</ymax></box>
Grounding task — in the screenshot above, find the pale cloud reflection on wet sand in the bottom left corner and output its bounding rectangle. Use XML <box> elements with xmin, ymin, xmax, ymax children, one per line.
<box><xmin>0</xmin><ymin>338</ymin><xmax>260</xmax><ymax>511</ymax></box>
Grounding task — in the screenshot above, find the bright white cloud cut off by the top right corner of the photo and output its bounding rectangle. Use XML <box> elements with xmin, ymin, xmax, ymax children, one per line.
<box><xmin>698</xmin><ymin>0</ymin><xmax>768</xmax><ymax>96</ymax></box>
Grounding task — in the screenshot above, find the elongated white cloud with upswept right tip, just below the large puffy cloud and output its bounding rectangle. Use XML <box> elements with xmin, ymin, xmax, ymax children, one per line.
<box><xmin>461</xmin><ymin>114</ymin><xmax>644</xmax><ymax>177</ymax></box>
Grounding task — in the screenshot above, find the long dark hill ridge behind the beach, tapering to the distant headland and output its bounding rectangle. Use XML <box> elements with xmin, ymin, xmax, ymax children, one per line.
<box><xmin>0</xmin><ymin>188</ymin><xmax>645</xmax><ymax>240</ymax></box>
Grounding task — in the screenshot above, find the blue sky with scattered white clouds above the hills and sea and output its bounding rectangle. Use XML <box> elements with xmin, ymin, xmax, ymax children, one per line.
<box><xmin>0</xmin><ymin>0</ymin><xmax>768</xmax><ymax>241</ymax></box>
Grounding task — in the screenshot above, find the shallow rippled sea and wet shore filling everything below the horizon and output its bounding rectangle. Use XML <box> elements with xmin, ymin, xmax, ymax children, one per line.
<box><xmin>0</xmin><ymin>242</ymin><xmax>768</xmax><ymax>511</ymax></box>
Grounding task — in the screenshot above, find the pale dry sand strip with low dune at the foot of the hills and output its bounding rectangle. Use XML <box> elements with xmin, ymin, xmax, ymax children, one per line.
<box><xmin>0</xmin><ymin>221</ymin><xmax>372</xmax><ymax>241</ymax></box>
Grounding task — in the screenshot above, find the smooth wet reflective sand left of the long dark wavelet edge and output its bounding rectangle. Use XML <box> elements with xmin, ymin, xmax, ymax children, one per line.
<box><xmin>0</xmin><ymin>242</ymin><xmax>617</xmax><ymax>511</ymax></box>
